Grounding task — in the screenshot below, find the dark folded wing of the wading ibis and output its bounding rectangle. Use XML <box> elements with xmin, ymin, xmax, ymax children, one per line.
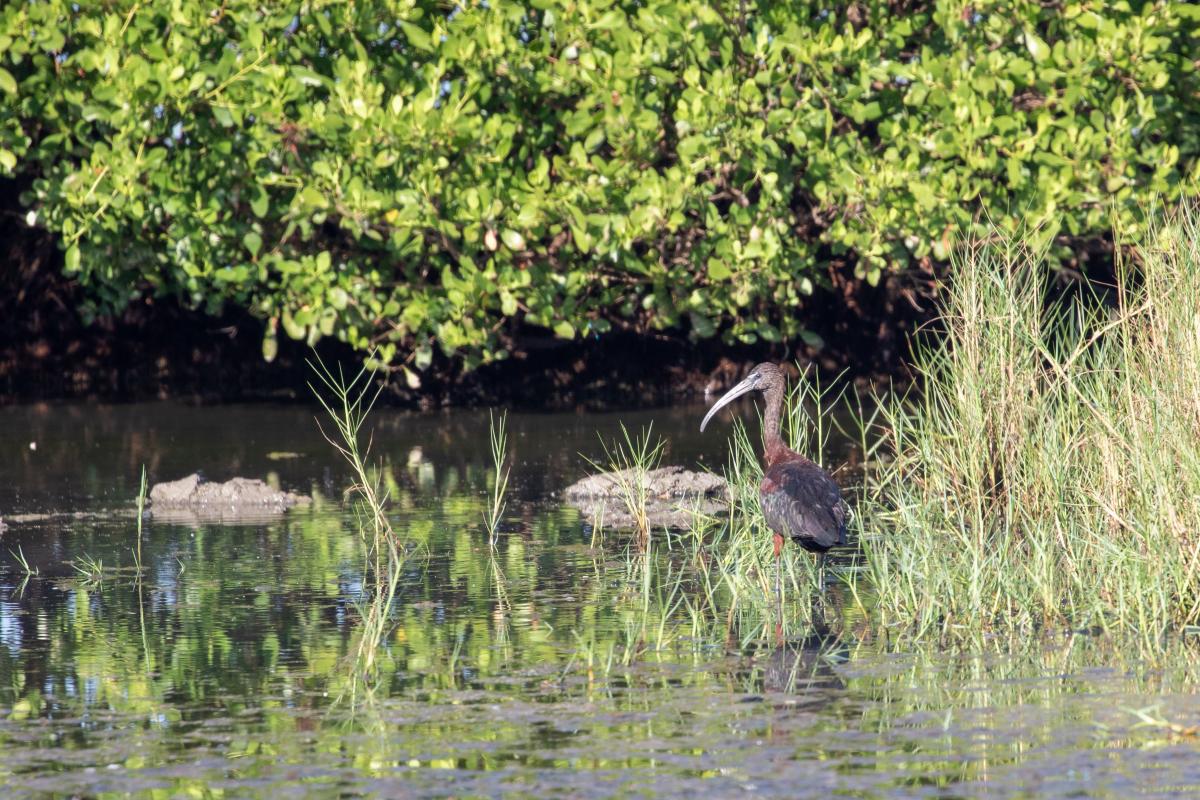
<box><xmin>760</xmin><ymin>461</ymin><xmax>846</xmax><ymax>551</ymax></box>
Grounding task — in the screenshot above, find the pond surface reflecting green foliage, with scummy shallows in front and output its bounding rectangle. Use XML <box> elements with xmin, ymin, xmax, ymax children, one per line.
<box><xmin>0</xmin><ymin>404</ymin><xmax>1200</xmax><ymax>798</ymax></box>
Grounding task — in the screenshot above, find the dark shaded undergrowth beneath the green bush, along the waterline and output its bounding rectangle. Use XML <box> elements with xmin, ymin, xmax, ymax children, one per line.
<box><xmin>0</xmin><ymin>181</ymin><xmax>932</xmax><ymax>408</ymax></box>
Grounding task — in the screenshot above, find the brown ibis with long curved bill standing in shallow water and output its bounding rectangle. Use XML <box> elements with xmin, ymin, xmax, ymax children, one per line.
<box><xmin>700</xmin><ymin>362</ymin><xmax>847</xmax><ymax>603</ymax></box>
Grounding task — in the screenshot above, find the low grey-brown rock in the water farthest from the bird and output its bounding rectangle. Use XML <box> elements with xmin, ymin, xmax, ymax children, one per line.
<box><xmin>150</xmin><ymin>473</ymin><xmax>312</xmax><ymax>522</ymax></box>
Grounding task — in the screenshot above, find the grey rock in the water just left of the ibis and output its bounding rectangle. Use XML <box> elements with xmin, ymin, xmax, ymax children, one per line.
<box><xmin>564</xmin><ymin>467</ymin><xmax>730</xmax><ymax>529</ymax></box>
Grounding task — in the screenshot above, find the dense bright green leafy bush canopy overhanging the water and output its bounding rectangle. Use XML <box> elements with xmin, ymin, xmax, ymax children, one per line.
<box><xmin>0</xmin><ymin>0</ymin><xmax>1200</xmax><ymax>380</ymax></box>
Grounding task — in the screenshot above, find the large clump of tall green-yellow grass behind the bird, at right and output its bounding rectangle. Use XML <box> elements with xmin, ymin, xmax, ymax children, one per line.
<box><xmin>857</xmin><ymin>207</ymin><xmax>1200</xmax><ymax>643</ymax></box>
